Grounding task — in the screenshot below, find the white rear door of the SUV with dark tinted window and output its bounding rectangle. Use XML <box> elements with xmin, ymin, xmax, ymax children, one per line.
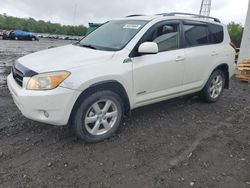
<box><xmin>183</xmin><ymin>21</ymin><xmax>215</xmax><ymax>90</ymax></box>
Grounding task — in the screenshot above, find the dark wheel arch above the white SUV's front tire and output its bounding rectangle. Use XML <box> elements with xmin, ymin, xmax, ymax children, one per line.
<box><xmin>70</xmin><ymin>80</ymin><xmax>130</xmax><ymax>120</ymax></box>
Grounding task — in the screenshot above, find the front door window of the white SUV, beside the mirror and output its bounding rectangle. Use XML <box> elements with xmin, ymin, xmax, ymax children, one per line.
<box><xmin>143</xmin><ymin>24</ymin><xmax>180</xmax><ymax>52</ymax></box>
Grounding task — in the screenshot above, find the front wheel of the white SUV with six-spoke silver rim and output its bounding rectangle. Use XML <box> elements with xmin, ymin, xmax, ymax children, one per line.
<box><xmin>71</xmin><ymin>90</ymin><xmax>124</xmax><ymax>143</ymax></box>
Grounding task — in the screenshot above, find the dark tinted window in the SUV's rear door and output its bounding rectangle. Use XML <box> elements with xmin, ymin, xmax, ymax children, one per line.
<box><xmin>184</xmin><ymin>24</ymin><xmax>210</xmax><ymax>47</ymax></box>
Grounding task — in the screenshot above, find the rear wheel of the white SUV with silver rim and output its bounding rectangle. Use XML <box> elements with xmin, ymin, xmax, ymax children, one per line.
<box><xmin>200</xmin><ymin>69</ymin><xmax>226</xmax><ymax>103</ymax></box>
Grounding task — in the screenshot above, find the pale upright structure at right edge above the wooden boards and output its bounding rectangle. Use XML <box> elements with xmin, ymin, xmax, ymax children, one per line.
<box><xmin>238</xmin><ymin>1</ymin><xmax>250</xmax><ymax>63</ymax></box>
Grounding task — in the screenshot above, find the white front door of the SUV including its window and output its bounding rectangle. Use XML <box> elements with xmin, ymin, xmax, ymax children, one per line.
<box><xmin>132</xmin><ymin>22</ymin><xmax>185</xmax><ymax>106</ymax></box>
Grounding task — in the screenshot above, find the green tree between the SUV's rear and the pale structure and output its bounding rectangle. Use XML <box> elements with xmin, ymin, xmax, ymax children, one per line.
<box><xmin>227</xmin><ymin>22</ymin><xmax>244</xmax><ymax>48</ymax></box>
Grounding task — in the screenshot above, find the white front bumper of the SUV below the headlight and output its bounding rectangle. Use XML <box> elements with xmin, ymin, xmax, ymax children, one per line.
<box><xmin>7</xmin><ymin>74</ymin><xmax>80</xmax><ymax>126</ymax></box>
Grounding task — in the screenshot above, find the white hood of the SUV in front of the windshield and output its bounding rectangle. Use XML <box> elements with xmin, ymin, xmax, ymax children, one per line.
<box><xmin>18</xmin><ymin>45</ymin><xmax>114</xmax><ymax>73</ymax></box>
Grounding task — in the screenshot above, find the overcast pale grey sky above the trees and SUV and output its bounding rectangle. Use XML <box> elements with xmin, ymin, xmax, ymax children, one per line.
<box><xmin>0</xmin><ymin>0</ymin><xmax>248</xmax><ymax>25</ymax></box>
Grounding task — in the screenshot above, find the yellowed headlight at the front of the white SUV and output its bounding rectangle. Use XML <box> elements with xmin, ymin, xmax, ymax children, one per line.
<box><xmin>26</xmin><ymin>71</ymin><xmax>70</xmax><ymax>90</ymax></box>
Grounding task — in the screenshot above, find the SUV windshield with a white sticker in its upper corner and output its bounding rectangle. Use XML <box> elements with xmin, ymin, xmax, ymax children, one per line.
<box><xmin>79</xmin><ymin>20</ymin><xmax>147</xmax><ymax>51</ymax></box>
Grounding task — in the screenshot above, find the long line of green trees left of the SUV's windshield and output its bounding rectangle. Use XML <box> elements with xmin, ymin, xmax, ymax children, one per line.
<box><xmin>0</xmin><ymin>14</ymin><xmax>87</xmax><ymax>36</ymax></box>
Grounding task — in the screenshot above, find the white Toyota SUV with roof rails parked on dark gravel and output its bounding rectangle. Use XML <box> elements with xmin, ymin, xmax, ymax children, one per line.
<box><xmin>8</xmin><ymin>13</ymin><xmax>236</xmax><ymax>142</ymax></box>
